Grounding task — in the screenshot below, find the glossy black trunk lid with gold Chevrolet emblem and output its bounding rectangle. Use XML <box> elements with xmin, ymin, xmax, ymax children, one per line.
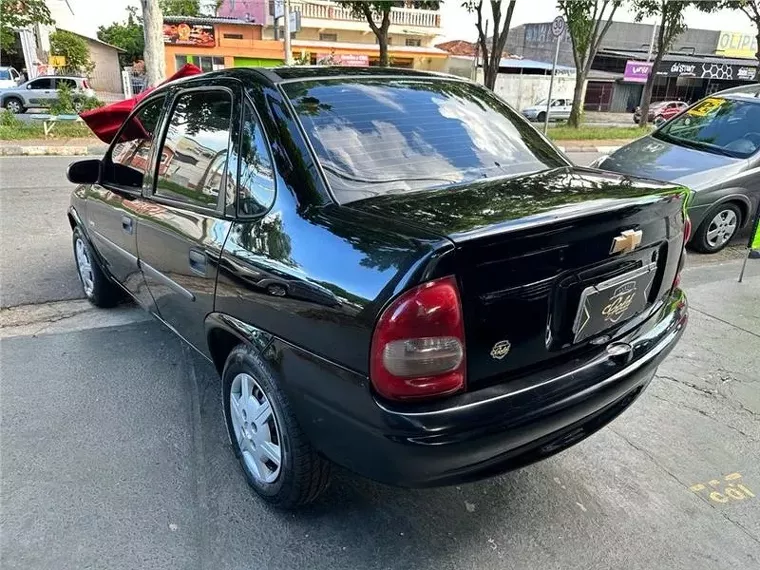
<box><xmin>350</xmin><ymin>168</ymin><xmax>688</xmax><ymax>388</ymax></box>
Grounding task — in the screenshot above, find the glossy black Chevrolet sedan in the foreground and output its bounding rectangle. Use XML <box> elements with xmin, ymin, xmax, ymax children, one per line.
<box><xmin>68</xmin><ymin>67</ymin><xmax>688</xmax><ymax>507</ymax></box>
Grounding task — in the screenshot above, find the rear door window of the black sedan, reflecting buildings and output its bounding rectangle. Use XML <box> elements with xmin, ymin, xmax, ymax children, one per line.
<box><xmin>156</xmin><ymin>91</ymin><xmax>234</xmax><ymax>208</ymax></box>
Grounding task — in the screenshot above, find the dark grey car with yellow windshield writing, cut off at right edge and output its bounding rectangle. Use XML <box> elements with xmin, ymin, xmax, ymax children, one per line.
<box><xmin>594</xmin><ymin>83</ymin><xmax>760</xmax><ymax>253</ymax></box>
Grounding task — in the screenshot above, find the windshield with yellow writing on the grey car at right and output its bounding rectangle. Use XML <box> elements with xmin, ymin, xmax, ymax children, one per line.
<box><xmin>652</xmin><ymin>97</ymin><xmax>760</xmax><ymax>158</ymax></box>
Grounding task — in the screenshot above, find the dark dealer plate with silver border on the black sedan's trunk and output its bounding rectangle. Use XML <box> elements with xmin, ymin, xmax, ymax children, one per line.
<box><xmin>573</xmin><ymin>263</ymin><xmax>657</xmax><ymax>342</ymax></box>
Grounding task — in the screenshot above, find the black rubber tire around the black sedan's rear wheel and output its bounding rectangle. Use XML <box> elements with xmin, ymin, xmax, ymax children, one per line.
<box><xmin>222</xmin><ymin>345</ymin><xmax>331</xmax><ymax>509</ymax></box>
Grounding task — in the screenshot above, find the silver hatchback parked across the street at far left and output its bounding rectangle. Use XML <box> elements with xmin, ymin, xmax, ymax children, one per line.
<box><xmin>0</xmin><ymin>75</ymin><xmax>95</xmax><ymax>113</ymax></box>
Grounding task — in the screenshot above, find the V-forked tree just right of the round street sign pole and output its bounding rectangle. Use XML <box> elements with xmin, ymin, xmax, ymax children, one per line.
<box><xmin>557</xmin><ymin>0</ymin><xmax>622</xmax><ymax>128</ymax></box>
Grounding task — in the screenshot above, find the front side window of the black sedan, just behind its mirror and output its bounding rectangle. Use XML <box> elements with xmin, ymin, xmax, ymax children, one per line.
<box><xmin>111</xmin><ymin>97</ymin><xmax>166</xmax><ymax>188</ymax></box>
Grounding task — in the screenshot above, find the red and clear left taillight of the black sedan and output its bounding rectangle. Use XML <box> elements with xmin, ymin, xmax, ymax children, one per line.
<box><xmin>370</xmin><ymin>276</ymin><xmax>465</xmax><ymax>400</ymax></box>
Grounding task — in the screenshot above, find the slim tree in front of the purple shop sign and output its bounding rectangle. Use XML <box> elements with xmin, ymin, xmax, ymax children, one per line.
<box><xmin>634</xmin><ymin>0</ymin><xmax>691</xmax><ymax>128</ymax></box>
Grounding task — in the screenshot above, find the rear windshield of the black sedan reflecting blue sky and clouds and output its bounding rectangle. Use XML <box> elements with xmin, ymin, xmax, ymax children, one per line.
<box><xmin>283</xmin><ymin>78</ymin><xmax>567</xmax><ymax>203</ymax></box>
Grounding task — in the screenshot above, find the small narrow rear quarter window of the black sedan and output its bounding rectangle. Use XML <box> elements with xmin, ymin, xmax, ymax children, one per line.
<box><xmin>233</xmin><ymin>105</ymin><xmax>274</xmax><ymax>216</ymax></box>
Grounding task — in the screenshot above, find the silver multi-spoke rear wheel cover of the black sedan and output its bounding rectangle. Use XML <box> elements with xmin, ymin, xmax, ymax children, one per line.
<box><xmin>230</xmin><ymin>372</ymin><xmax>282</xmax><ymax>483</ymax></box>
